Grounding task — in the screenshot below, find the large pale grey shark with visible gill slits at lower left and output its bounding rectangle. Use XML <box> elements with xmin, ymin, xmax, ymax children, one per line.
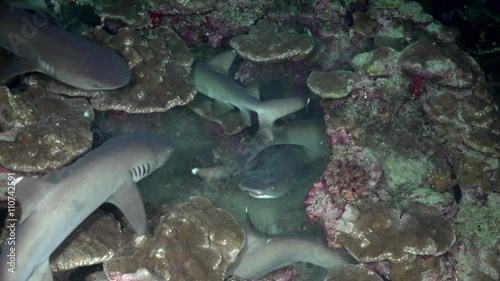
<box><xmin>0</xmin><ymin>133</ymin><xmax>173</xmax><ymax>281</ymax></box>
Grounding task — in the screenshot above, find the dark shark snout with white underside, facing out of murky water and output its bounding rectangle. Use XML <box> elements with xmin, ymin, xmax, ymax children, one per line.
<box><xmin>240</xmin><ymin>172</ymin><xmax>292</xmax><ymax>199</ymax></box>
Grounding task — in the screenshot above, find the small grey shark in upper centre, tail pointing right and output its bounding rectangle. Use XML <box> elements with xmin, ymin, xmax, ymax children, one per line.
<box><xmin>191</xmin><ymin>51</ymin><xmax>309</xmax><ymax>138</ymax></box>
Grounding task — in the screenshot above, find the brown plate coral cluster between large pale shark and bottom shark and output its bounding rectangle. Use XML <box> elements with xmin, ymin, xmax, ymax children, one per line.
<box><xmin>48</xmin><ymin>197</ymin><xmax>245</xmax><ymax>280</ymax></box>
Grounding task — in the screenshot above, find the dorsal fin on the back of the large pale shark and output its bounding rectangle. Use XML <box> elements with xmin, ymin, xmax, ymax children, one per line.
<box><xmin>14</xmin><ymin>177</ymin><xmax>53</xmax><ymax>223</ymax></box>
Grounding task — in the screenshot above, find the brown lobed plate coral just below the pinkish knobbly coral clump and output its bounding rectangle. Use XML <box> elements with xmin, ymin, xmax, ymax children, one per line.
<box><xmin>337</xmin><ymin>200</ymin><xmax>455</xmax><ymax>263</ymax></box>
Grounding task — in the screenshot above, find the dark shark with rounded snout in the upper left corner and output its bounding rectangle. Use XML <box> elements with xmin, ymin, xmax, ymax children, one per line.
<box><xmin>0</xmin><ymin>1</ymin><xmax>131</xmax><ymax>90</ymax></box>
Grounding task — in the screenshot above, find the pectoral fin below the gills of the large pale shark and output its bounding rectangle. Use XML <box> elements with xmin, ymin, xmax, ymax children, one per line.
<box><xmin>108</xmin><ymin>181</ymin><xmax>147</xmax><ymax>235</ymax></box>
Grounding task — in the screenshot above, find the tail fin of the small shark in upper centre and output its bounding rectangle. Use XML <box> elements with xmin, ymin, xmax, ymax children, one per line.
<box><xmin>256</xmin><ymin>98</ymin><xmax>309</xmax><ymax>132</ymax></box>
